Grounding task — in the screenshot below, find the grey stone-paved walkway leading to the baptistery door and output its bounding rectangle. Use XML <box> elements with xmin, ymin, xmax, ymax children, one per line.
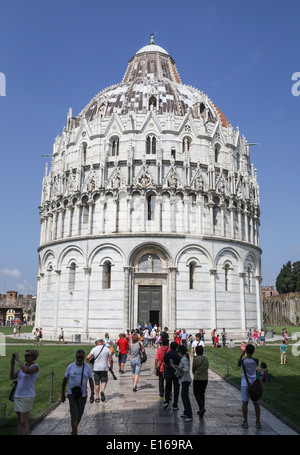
<box><xmin>31</xmin><ymin>348</ymin><xmax>298</xmax><ymax>436</ymax></box>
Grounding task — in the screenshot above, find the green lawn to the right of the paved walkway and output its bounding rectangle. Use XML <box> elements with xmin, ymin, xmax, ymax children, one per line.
<box><xmin>206</xmin><ymin>345</ymin><xmax>300</xmax><ymax>427</ymax></box>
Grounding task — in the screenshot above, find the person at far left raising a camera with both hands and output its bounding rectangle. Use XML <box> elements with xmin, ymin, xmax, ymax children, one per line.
<box><xmin>10</xmin><ymin>349</ymin><xmax>39</xmax><ymax>435</ymax></box>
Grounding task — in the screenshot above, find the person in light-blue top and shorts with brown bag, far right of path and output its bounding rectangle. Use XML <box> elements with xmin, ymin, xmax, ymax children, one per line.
<box><xmin>238</xmin><ymin>344</ymin><xmax>261</xmax><ymax>429</ymax></box>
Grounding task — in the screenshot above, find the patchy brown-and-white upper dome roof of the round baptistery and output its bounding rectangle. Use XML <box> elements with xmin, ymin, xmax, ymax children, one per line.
<box><xmin>77</xmin><ymin>40</ymin><xmax>229</xmax><ymax>126</ymax></box>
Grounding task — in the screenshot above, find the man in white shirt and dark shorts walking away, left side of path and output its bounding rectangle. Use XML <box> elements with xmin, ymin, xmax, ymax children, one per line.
<box><xmin>86</xmin><ymin>338</ymin><xmax>113</xmax><ymax>403</ymax></box>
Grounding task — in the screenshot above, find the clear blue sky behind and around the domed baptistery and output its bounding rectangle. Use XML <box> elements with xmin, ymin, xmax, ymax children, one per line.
<box><xmin>0</xmin><ymin>0</ymin><xmax>300</xmax><ymax>294</ymax></box>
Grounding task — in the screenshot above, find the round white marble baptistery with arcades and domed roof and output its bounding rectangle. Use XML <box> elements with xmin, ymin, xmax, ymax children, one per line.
<box><xmin>36</xmin><ymin>37</ymin><xmax>262</xmax><ymax>340</ymax></box>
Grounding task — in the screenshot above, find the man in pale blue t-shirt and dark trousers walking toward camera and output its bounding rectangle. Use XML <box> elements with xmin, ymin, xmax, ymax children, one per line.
<box><xmin>61</xmin><ymin>349</ymin><xmax>95</xmax><ymax>435</ymax></box>
